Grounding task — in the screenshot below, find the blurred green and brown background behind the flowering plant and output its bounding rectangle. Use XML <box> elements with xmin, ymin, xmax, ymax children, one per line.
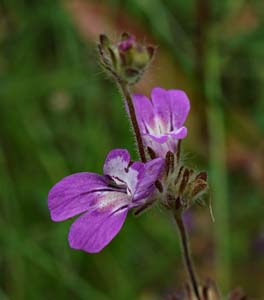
<box><xmin>0</xmin><ymin>0</ymin><xmax>264</xmax><ymax>300</ymax></box>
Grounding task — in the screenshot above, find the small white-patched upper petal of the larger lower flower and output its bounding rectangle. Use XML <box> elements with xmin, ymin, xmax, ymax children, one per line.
<box><xmin>104</xmin><ymin>149</ymin><xmax>130</xmax><ymax>182</ymax></box>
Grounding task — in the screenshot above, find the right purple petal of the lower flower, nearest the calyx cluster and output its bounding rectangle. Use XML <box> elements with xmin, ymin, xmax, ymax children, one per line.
<box><xmin>134</xmin><ymin>158</ymin><xmax>165</xmax><ymax>201</ymax></box>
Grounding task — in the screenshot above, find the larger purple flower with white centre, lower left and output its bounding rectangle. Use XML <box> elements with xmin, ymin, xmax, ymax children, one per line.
<box><xmin>48</xmin><ymin>149</ymin><xmax>164</xmax><ymax>253</ymax></box>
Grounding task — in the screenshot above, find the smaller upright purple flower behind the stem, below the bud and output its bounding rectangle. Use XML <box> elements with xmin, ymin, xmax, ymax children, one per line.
<box><xmin>133</xmin><ymin>87</ymin><xmax>190</xmax><ymax>157</ymax></box>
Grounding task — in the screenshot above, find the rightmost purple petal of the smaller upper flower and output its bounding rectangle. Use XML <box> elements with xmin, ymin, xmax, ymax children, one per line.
<box><xmin>167</xmin><ymin>90</ymin><xmax>190</xmax><ymax>130</ymax></box>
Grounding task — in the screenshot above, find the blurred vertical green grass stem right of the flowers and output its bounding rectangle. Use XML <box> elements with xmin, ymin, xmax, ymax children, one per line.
<box><xmin>205</xmin><ymin>31</ymin><xmax>231</xmax><ymax>291</ymax></box>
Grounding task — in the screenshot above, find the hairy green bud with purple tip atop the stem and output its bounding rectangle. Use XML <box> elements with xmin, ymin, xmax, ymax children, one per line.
<box><xmin>98</xmin><ymin>33</ymin><xmax>155</xmax><ymax>85</ymax></box>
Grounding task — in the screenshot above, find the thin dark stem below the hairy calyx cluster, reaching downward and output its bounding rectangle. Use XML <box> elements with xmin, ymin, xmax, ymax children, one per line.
<box><xmin>174</xmin><ymin>213</ymin><xmax>201</xmax><ymax>300</ymax></box>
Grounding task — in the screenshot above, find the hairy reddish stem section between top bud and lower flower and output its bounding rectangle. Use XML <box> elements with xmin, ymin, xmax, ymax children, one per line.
<box><xmin>119</xmin><ymin>82</ymin><xmax>147</xmax><ymax>162</ymax></box>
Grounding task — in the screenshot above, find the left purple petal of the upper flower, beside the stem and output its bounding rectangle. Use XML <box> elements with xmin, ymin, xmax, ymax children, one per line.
<box><xmin>133</xmin><ymin>94</ymin><xmax>155</xmax><ymax>133</ymax></box>
